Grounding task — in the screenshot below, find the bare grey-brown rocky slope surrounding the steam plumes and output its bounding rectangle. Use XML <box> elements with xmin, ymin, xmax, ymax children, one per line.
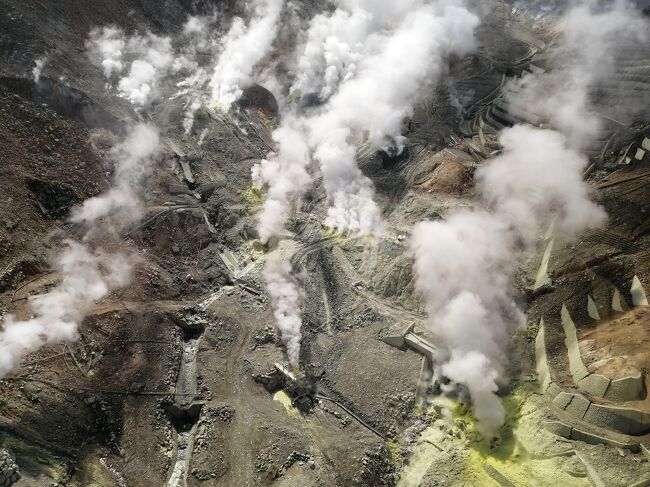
<box><xmin>0</xmin><ymin>0</ymin><xmax>650</xmax><ymax>487</ymax></box>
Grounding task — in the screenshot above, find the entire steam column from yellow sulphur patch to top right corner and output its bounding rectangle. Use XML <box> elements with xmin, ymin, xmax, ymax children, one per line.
<box><xmin>411</xmin><ymin>2</ymin><xmax>648</xmax><ymax>437</ymax></box>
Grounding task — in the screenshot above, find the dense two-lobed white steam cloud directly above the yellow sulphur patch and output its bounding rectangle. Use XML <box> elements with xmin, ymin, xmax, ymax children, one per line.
<box><xmin>411</xmin><ymin>125</ymin><xmax>605</xmax><ymax>436</ymax></box>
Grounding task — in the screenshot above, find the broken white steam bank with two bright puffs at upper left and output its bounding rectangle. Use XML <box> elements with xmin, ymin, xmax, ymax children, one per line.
<box><xmin>86</xmin><ymin>5</ymin><xmax>283</xmax><ymax>126</ymax></box>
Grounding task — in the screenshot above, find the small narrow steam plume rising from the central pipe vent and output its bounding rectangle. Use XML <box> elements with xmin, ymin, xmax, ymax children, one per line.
<box><xmin>264</xmin><ymin>254</ymin><xmax>304</xmax><ymax>368</ymax></box>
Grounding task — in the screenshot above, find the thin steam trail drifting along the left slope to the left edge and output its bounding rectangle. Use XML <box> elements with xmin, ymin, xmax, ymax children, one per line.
<box><xmin>0</xmin><ymin>124</ymin><xmax>158</xmax><ymax>377</ymax></box>
